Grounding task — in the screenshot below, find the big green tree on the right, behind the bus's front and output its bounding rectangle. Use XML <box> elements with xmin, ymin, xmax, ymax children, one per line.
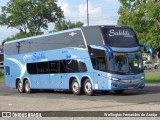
<box><xmin>118</xmin><ymin>0</ymin><xmax>160</xmax><ymax>56</ymax></box>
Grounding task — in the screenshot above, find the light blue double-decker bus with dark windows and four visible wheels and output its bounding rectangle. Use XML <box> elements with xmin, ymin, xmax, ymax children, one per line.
<box><xmin>4</xmin><ymin>26</ymin><xmax>153</xmax><ymax>95</ymax></box>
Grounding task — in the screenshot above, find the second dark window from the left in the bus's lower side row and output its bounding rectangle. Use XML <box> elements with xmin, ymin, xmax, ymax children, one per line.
<box><xmin>37</xmin><ymin>62</ymin><xmax>50</xmax><ymax>74</ymax></box>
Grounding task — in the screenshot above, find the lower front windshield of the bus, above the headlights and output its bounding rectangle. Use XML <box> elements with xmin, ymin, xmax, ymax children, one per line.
<box><xmin>108</xmin><ymin>52</ymin><xmax>143</xmax><ymax>74</ymax></box>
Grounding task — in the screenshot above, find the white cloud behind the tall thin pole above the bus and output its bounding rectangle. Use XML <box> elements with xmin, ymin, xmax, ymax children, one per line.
<box><xmin>59</xmin><ymin>0</ymin><xmax>117</xmax><ymax>25</ymax></box>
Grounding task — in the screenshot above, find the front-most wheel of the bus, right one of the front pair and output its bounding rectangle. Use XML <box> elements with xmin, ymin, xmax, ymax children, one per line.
<box><xmin>84</xmin><ymin>79</ymin><xmax>94</xmax><ymax>96</ymax></box>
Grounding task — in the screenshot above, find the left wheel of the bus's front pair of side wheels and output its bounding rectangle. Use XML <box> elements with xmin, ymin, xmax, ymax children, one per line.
<box><xmin>72</xmin><ymin>79</ymin><xmax>81</xmax><ymax>95</ymax></box>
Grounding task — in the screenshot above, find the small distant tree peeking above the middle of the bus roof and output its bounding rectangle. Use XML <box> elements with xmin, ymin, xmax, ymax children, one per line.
<box><xmin>53</xmin><ymin>20</ymin><xmax>83</xmax><ymax>31</ymax></box>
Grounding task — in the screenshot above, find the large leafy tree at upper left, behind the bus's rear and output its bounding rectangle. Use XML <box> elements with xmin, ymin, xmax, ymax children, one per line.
<box><xmin>0</xmin><ymin>0</ymin><xmax>64</xmax><ymax>35</ymax></box>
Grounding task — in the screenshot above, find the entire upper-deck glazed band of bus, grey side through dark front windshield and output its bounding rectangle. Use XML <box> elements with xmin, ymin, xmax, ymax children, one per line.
<box><xmin>5</xmin><ymin>25</ymin><xmax>139</xmax><ymax>55</ymax></box>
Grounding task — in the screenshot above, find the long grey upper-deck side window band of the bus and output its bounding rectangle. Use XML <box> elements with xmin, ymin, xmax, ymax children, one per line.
<box><xmin>5</xmin><ymin>30</ymin><xmax>86</xmax><ymax>55</ymax></box>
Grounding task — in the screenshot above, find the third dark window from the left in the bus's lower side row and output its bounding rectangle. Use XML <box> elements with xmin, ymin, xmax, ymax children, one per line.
<box><xmin>49</xmin><ymin>61</ymin><xmax>58</xmax><ymax>73</ymax></box>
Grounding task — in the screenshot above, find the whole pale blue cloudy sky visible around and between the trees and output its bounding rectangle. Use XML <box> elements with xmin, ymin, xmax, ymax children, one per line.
<box><xmin>0</xmin><ymin>0</ymin><xmax>120</xmax><ymax>44</ymax></box>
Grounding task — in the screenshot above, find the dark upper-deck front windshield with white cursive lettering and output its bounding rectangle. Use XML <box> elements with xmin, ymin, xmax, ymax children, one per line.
<box><xmin>101</xmin><ymin>27</ymin><xmax>138</xmax><ymax>47</ymax></box>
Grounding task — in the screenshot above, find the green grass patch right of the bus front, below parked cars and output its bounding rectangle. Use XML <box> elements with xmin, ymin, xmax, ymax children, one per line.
<box><xmin>145</xmin><ymin>71</ymin><xmax>160</xmax><ymax>83</ymax></box>
